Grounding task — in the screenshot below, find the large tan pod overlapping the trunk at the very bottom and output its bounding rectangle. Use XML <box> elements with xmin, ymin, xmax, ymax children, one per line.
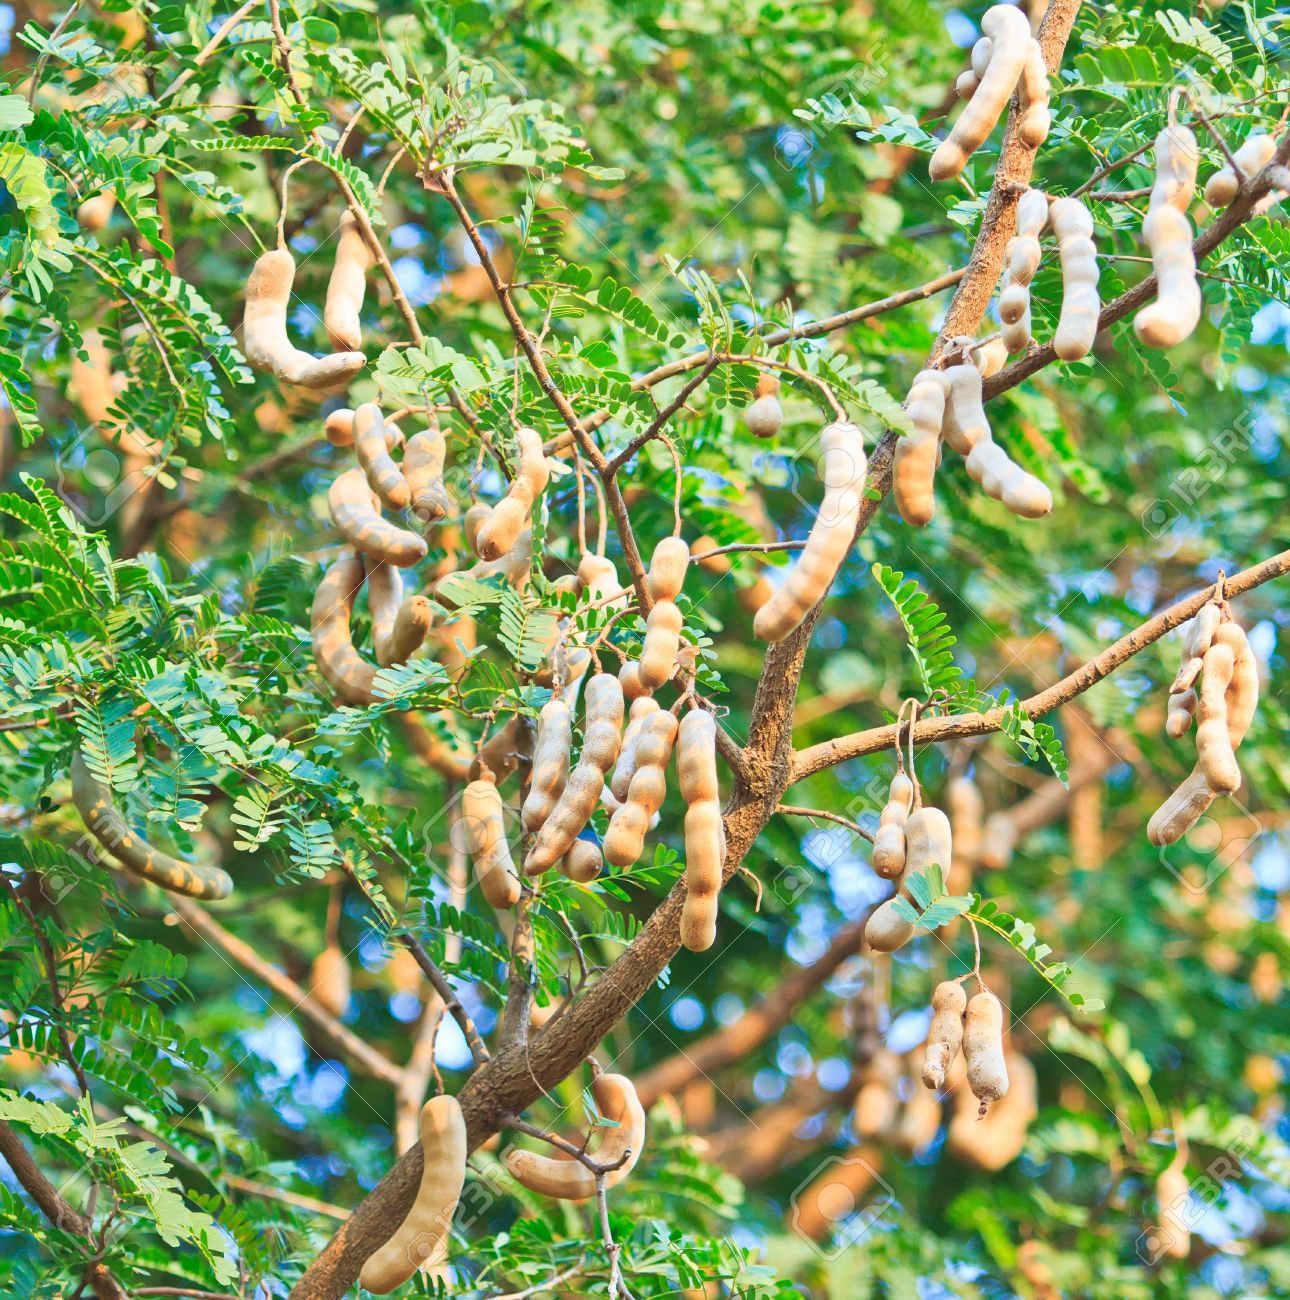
<box><xmin>359</xmin><ymin>1093</ymin><xmax>467</xmax><ymax>1296</ymax></box>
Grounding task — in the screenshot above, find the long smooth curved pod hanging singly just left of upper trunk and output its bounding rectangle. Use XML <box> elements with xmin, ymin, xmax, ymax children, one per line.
<box><xmin>753</xmin><ymin>423</ymin><xmax>869</xmax><ymax>642</ymax></box>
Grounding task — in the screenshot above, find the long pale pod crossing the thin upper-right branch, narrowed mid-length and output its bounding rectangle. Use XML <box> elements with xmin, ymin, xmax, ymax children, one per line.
<box><xmin>1133</xmin><ymin>125</ymin><xmax>1202</xmax><ymax>347</ymax></box>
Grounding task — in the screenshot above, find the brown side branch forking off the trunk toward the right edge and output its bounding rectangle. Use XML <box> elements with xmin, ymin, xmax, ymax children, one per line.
<box><xmin>792</xmin><ymin>551</ymin><xmax>1290</xmax><ymax>781</ymax></box>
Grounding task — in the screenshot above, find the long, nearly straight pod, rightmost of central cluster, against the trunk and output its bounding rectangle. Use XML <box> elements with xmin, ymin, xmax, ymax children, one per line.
<box><xmin>676</xmin><ymin>709</ymin><xmax>726</xmax><ymax>953</ymax></box>
